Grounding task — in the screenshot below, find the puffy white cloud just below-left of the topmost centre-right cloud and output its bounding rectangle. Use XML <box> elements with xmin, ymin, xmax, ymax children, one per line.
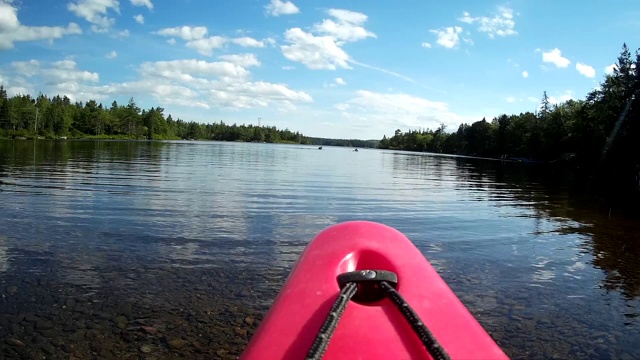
<box><xmin>280</xmin><ymin>28</ymin><xmax>351</xmax><ymax>70</ymax></box>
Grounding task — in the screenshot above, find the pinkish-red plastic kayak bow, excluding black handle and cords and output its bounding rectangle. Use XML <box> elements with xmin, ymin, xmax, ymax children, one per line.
<box><xmin>240</xmin><ymin>221</ymin><xmax>507</xmax><ymax>359</ymax></box>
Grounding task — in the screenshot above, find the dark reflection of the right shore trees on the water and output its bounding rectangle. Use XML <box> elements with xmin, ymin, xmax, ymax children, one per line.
<box><xmin>440</xmin><ymin>158</ymin><xmax>640</xmax><ymax>299</ymax></box>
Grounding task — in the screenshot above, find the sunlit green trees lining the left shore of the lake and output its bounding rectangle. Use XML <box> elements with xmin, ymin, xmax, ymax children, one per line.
<box><xmin>0</xmin><ymin>90</ymin><xmax>311</xmax><ymax>144</ymax></box>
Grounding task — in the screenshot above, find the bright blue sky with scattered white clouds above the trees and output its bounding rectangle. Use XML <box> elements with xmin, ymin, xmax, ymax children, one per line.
<box><xmin>0</xmin><ymin>0</ymin><xmax>640</xmax><ymax>139</ymax></box>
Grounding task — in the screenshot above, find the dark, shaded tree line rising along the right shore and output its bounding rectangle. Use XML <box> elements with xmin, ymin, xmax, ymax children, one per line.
<box><xmin>378</xmin><ymin>43</ymin><xmax>640</xmax><ymax>202</ymax></box>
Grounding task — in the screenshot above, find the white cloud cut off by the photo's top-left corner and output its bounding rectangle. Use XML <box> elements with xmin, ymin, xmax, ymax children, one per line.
<box><xmin>0</xmin><ymin>1</ymin><xmax>82</xmax><ymax>50</ymax></box>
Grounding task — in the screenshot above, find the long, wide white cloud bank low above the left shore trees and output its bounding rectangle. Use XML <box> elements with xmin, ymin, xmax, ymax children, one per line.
<box><xmin>3</xmin><ymin>54</ymin><xmax>313</xmax><ymax>110</ymax></box>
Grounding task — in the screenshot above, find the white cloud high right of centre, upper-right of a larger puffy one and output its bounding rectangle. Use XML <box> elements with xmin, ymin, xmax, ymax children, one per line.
<box><xmin>313</xmin><ymin>9</ymin><xmax>376</xmax><ymax>43</ymax></box>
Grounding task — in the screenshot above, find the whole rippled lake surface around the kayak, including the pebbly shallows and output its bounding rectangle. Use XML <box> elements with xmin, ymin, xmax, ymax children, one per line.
<box><xmin>0</xmin><ymin>141</ymin><xmax>640</xmax><ymax>359</ymax></box>
